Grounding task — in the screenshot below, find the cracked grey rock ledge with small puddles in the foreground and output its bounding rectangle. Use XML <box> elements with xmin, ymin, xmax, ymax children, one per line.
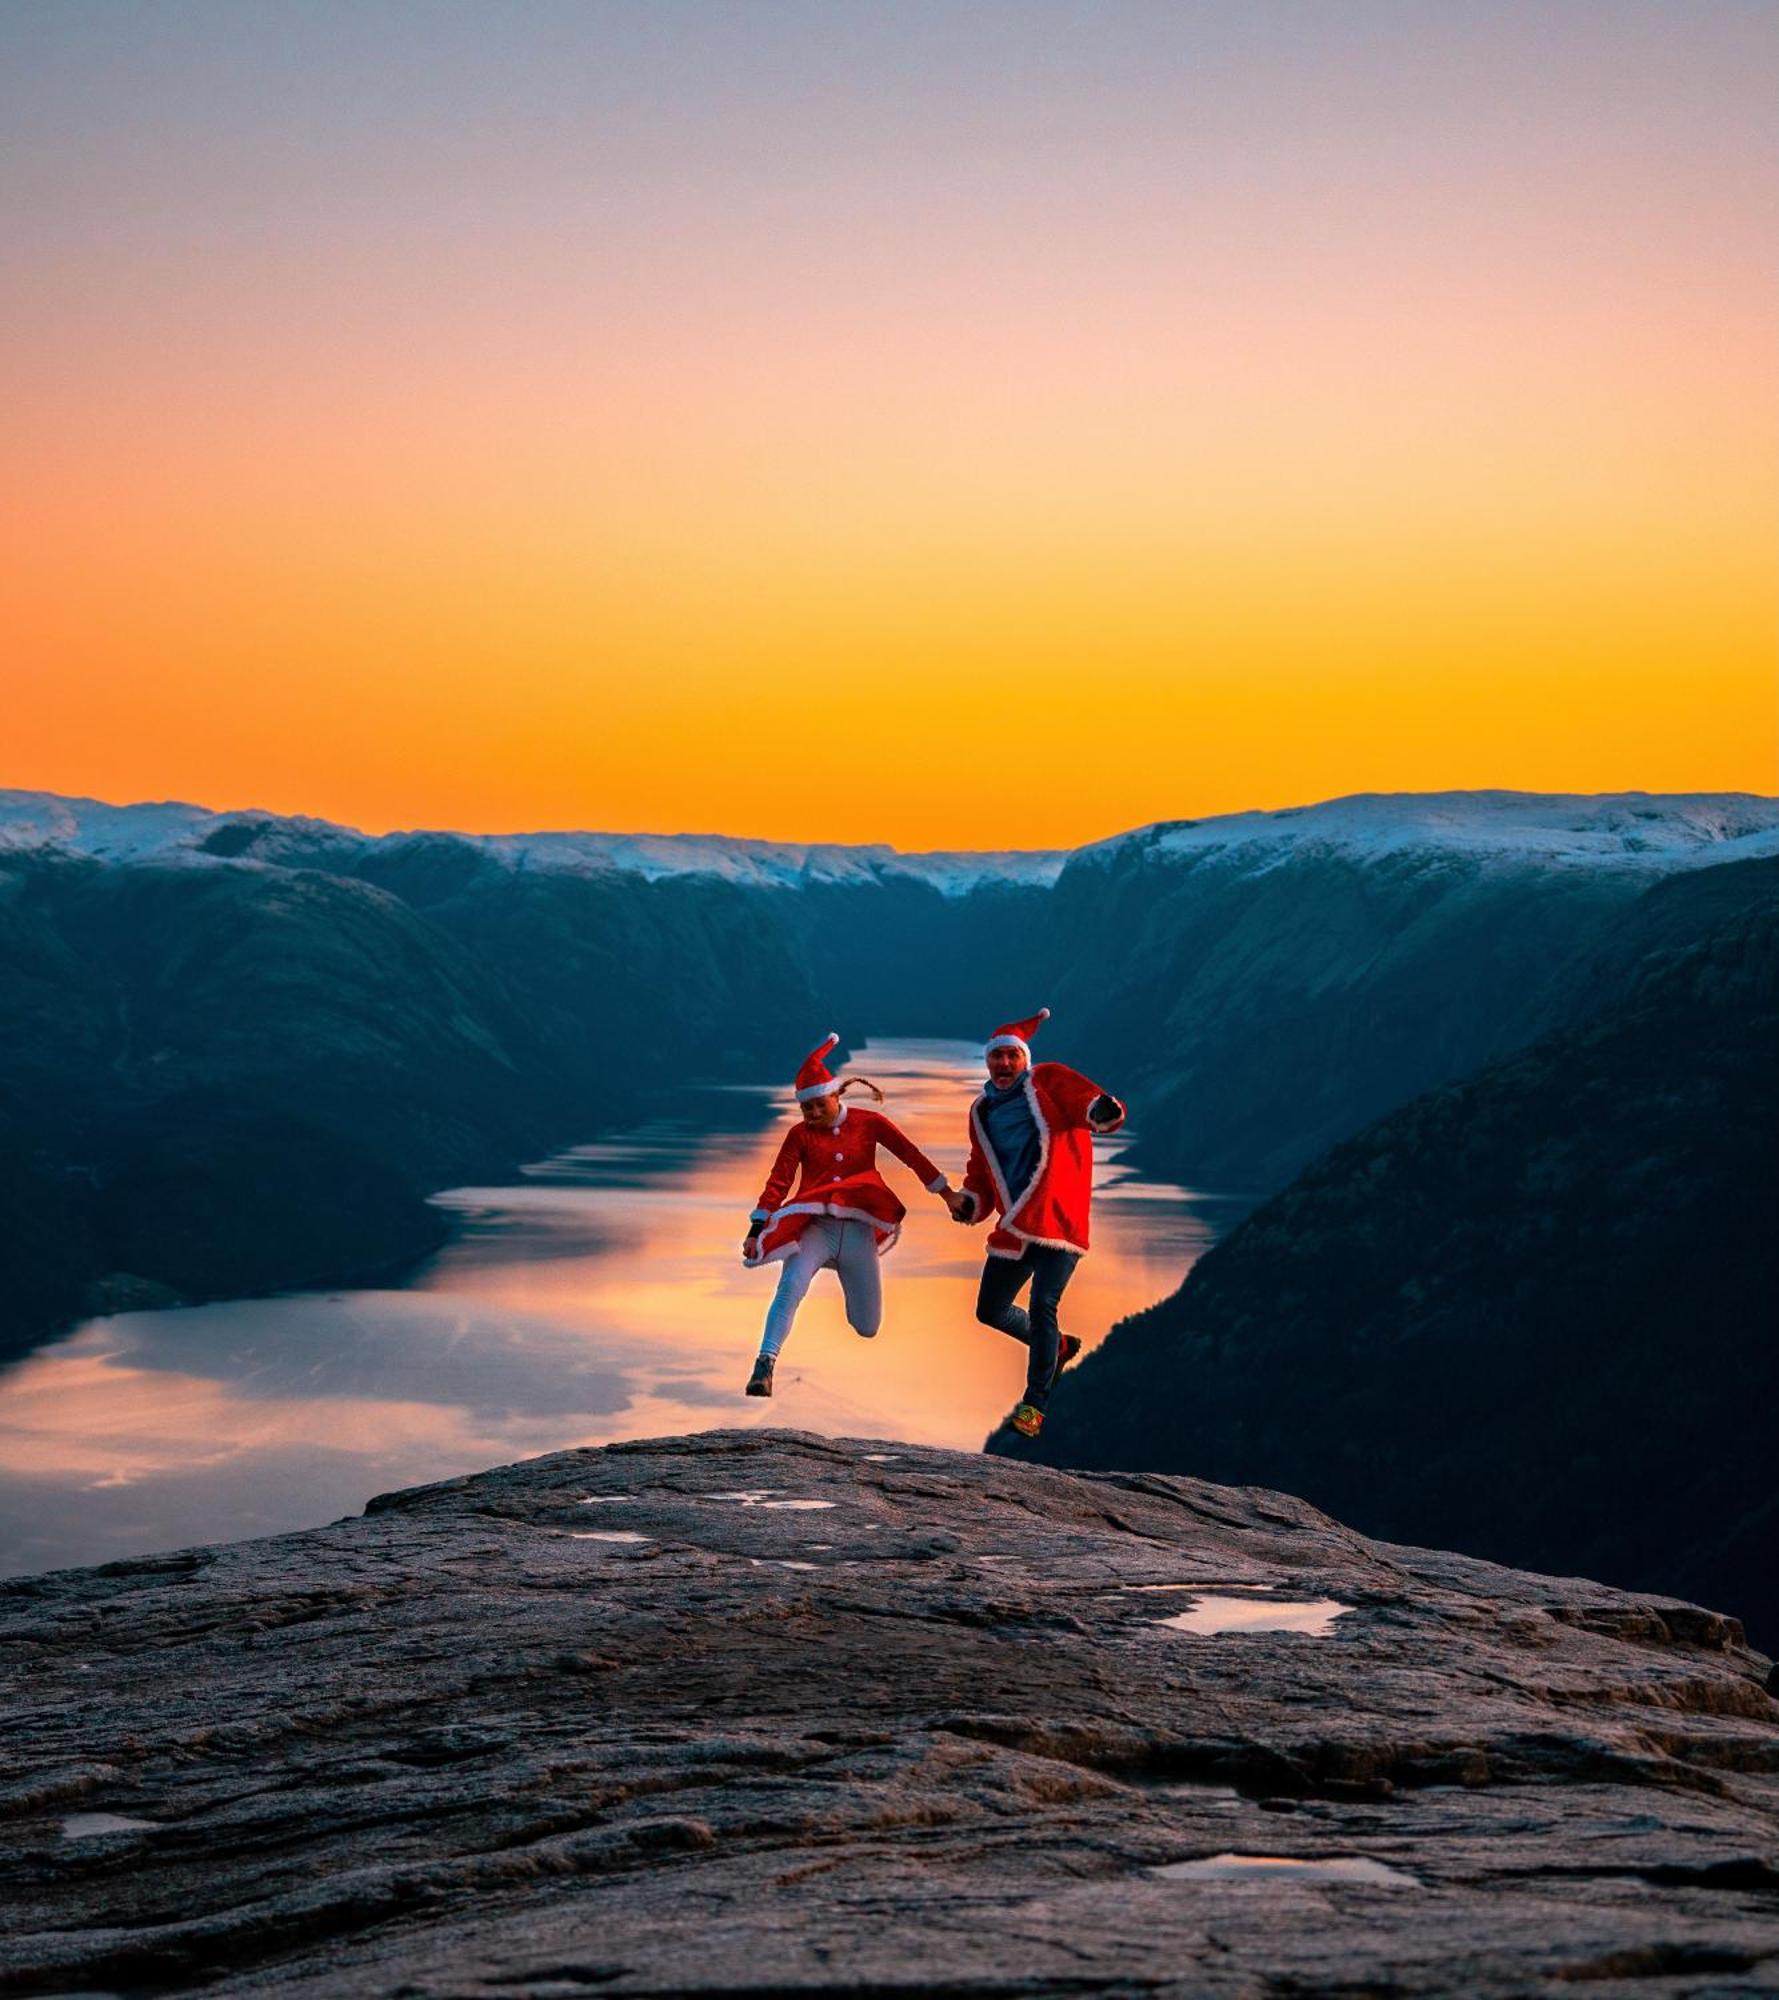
<box><xmin>0</xmin><ymin>1430</ymin><xmax>1779</xmax><ymax>2000</ymax></box>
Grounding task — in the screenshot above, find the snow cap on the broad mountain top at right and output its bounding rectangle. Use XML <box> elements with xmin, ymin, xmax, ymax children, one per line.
<box><xmin>1073</xmin><ymin>792</ymin><xmax>1779</xmax><ymax>870</ymax></box>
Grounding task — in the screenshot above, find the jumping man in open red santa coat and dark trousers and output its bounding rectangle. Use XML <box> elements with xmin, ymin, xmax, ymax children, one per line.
<box><xmin>945</xmin><ymin>1008</ymin><xmax>1125</xmax><ymax>1438</ymax></box>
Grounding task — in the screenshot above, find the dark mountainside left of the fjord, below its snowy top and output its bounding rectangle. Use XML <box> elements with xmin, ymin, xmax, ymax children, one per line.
<box><xmin>0</xmin><ymin>852</ymin><xmax>818</xmax><ymax>1354</ymax></box>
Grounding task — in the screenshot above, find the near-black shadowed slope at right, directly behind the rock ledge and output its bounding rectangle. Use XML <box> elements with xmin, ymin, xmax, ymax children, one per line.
<box><xmin>993</xmin><ymin>862</ymin><xmax>1779</xmax><ymax>1636</ymax></box>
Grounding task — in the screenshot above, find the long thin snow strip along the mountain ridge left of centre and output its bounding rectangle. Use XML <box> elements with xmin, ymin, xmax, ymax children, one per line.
<box><xmin>0</xmin><ymin>790</ymin><xmax>1067</xmax><ymax>896</ymax></box>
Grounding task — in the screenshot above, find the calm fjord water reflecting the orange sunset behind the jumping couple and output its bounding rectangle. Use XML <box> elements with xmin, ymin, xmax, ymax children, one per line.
<box><xmin>0</xmin><ymin>1040</ymin><xmax>1229</xmax><ymax>1574</ymax></box>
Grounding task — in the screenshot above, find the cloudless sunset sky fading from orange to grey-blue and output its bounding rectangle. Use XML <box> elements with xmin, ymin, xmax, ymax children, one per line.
<box><xmin>0</xmin><ymin>0</ymin><xmax>1779</xmax><ymax>846</ymax></box>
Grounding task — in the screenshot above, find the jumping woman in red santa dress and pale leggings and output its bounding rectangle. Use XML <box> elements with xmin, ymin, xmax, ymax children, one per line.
<box><xmin>742</xmin><ymin>1034</ymin><xmax>953</xmax><ymax>1396</ymax></box>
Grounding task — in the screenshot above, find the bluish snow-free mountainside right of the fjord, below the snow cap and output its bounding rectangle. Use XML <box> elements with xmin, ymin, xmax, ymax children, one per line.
<box><xmin>1049</xmin><ymin>840</ymin><xmax>1679</xmax><ymax>1188</ymax></box>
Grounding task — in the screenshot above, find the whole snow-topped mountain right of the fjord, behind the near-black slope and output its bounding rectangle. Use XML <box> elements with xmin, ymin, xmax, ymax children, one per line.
<box><xmin>1049</xmin><ymin>792</ymin><xmax>1779</xmax><ymax>1190</ymax></box>
